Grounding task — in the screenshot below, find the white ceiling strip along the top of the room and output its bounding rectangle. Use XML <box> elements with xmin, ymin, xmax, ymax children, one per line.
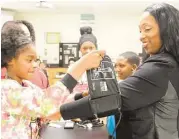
<box><xmin>1</xmin><ymin>0</ymin><xmax>179</xmax><ymax>14</ymax></box>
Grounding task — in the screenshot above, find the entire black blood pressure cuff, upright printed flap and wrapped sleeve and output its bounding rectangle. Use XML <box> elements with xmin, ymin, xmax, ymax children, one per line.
<box><xmin>60</xmin><ymin>56</ymin><xmax>121</xmax><ymax>120</ymax></box>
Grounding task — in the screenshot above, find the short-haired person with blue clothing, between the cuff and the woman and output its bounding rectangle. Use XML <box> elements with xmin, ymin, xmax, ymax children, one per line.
<box><xmin>107</xmin><ymin>51</ymin><xmax>140</xmax><ymax>139</ymax></box>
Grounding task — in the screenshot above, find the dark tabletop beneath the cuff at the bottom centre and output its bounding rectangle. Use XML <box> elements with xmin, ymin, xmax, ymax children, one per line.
<box><xmin>42</xmin><ymin>122</ymin><xmax>108</xmax><ymax>139</ymax></box>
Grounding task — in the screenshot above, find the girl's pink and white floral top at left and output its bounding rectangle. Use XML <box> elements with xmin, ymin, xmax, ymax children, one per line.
<box><xmin>1</xmin><ymin>79</ymin><xmax>74</xmax><ymax>139</ymax></box>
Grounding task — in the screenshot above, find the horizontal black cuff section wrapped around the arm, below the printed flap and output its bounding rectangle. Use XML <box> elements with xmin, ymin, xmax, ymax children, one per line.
<box><xmin>60</xmin><ymin>95</ymin><xmax>120</xmax><ymax>120</ymax></box>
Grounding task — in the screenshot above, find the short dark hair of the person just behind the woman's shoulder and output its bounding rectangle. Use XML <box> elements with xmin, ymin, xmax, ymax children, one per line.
<box><xmin>119</xmin><ymin>51</ymin><xmax>140</xmax><ymax>66</ymax></box>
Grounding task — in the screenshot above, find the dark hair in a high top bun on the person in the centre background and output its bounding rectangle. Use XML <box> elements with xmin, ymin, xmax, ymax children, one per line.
<box><xmin>79</xmin><ymin>26</ymin><xmax>97</xmax><ymax>50</ymax></box>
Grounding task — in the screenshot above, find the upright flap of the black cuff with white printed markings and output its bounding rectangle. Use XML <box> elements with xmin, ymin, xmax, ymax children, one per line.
<box><xmin>87</xmin><ymin>55</ymin><xmax>121</xmax><ymax>118</ymax></box>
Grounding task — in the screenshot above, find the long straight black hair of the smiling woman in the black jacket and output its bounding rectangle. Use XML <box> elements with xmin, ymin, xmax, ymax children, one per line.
<box><xmin>145</xmin><ymin>3</ymin><xmax>179</xmax><ymax>62</ymax></box>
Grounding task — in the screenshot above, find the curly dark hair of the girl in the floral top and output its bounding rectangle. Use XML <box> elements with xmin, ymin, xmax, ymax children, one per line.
<box><xmin>1</xmin><ymin>22</ymin><xmax>32</xmax><ymax>67</ymax></box>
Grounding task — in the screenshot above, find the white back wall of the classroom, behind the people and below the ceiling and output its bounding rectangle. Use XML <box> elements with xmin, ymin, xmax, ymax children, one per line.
<box><xmin>15</xmin><ymin>11</ymin><xmax>141</xmax><ymax>62</ymax></box>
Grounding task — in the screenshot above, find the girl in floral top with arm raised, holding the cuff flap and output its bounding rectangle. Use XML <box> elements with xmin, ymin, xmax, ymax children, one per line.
<box><xmin>1</xmin><ymin>22</ymin><xmax>105</xmax><ymax>139</ymax></box>
